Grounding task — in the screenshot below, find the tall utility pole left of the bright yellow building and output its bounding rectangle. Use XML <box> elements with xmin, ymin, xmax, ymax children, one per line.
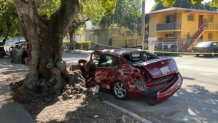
<box><xmin>141</xmin><ymin>0</ymin><xmax>145</xmax><ymax>50</ymax></box>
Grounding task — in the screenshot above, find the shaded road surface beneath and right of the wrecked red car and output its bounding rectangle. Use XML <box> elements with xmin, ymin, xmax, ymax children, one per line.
<box><xmin>93</xmin><ymin>85</ymin><xmax>218</xmax><ymax>123</ymax></box>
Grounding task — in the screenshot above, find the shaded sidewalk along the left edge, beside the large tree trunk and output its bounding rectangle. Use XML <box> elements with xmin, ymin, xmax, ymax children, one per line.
<box><xmin>0</xmin><ymin>59</ymin><xmax>35</xmax><ymax>123</ymax></box>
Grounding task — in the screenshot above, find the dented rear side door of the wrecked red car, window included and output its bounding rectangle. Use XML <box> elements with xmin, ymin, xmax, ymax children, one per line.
<box><xmin>95</xmin><ymin>54</ymin><xmax>118</xmax><ymax>89</ymax></box>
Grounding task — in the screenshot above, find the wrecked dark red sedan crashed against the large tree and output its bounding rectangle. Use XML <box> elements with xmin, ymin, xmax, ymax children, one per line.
<box><xmin>71</xmin><ymin>48</ymin><xmax>183</xmax><ymax>104</ymax></box>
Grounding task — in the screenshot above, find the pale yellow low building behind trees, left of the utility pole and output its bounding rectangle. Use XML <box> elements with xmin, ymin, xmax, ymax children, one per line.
<box><xmin>85</xmin><ymin>25</ymin><xmax>142</xmax><ymax>48</ymax></box>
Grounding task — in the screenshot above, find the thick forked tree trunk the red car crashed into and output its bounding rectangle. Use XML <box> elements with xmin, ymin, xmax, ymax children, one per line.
<box><xmin>11</xmin><ymin>0</ymin><xmax>79</xmax><ymax>101</ymax></box>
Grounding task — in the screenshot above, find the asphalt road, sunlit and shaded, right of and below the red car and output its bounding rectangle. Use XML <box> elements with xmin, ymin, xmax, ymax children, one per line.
<box><xmin>100</xmin><ymin>55</ymin><xmax>218</xmax><ymax>123</ymax></box>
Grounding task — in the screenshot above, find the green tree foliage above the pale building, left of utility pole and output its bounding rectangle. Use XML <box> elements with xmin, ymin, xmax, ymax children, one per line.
<box><xmin>99</xmin><ymin>0</ymin><xmax>141</xmax><ymax>31</ymax></box>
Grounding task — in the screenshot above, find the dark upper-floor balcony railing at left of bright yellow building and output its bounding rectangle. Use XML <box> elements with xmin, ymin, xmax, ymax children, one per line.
<box><xmin>156</xmin><ymin>23</ymin><xmax>181</xmax><ymax>31</ymax></box>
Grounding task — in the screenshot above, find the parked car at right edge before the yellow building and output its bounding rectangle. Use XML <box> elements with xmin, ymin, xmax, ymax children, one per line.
<box><xmin>193</xmin><ymin>41</ymin><xmax>218</xmax><ymax>56</ymax></box>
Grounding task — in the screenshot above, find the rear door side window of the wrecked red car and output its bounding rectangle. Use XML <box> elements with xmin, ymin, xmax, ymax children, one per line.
<box><xmin>98</xmin><ymin>55</ymin><xmax>117</xmax><ymax>67</ymax></box>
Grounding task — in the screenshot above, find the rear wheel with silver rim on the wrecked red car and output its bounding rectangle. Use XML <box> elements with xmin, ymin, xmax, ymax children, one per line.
<box><xmin>112</xmin><ymin>82</ymin><xmax>128</xmax><ymax>100</ymax></box>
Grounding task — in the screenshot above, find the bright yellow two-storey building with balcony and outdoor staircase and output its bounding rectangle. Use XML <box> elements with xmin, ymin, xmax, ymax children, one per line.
<box><xmin>148</xmin><ymin>7</ymin><xmax>218</xmax><ymax>51</ymax></box>
